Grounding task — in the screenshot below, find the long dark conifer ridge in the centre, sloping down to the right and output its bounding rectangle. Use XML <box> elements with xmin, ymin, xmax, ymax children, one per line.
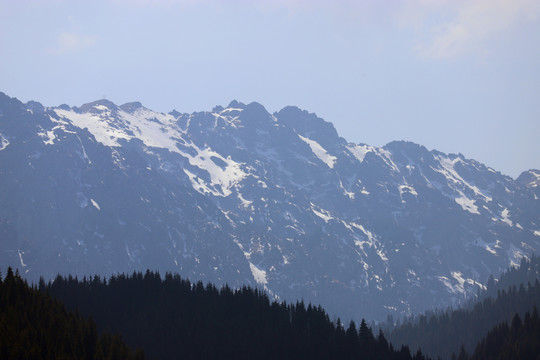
<box><xmin>40</xmin><ymin>271</ymin><xmax>424</xmax><ymax>359</ymax></box>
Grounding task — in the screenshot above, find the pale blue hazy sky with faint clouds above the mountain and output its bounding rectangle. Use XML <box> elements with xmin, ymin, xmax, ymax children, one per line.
<box><xmin>0</xmin><ymin>0</ymin><xmax>540</xmax><ymax>177</ymax></box>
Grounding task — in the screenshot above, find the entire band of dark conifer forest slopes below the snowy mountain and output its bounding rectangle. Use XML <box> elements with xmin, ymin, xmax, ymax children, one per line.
<box><xmin>4</xmin><ymin>256</ymin><xmax>540</xmax><ymax>360</ymax></box>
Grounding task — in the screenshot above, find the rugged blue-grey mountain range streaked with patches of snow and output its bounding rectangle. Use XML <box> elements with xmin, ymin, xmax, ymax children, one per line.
<box><xmin>0</xmin><ymin>93</ymin><xmax>540</xmax><ymax>319</ymax></box>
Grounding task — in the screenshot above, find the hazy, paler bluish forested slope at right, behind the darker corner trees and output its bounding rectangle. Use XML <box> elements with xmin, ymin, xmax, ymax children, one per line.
<box><xmin>383</xmin><ymin>256</ymin><xmax>540</xmax><ymax>358</ymax></box>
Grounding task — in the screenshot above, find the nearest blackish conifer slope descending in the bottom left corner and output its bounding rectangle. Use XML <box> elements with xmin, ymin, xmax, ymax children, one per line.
<box><xmin>0</xmin><ymin>268</ymin><xmax>144</xmax><ymax>360</ymax></box>
